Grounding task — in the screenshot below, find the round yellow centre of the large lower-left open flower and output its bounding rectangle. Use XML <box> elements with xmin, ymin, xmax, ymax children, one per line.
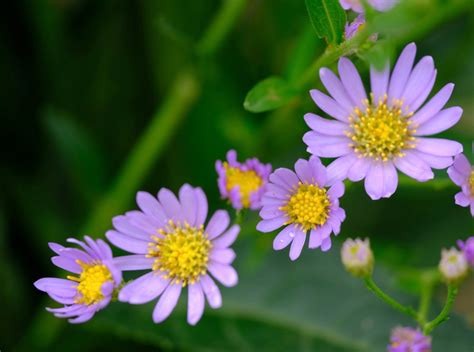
<box><xmin>147</xmin><ymin>221</ymin><xmax>212</xmax><ymax>286</ymax></box>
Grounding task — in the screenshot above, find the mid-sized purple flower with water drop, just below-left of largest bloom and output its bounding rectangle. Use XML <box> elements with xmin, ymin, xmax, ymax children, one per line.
<box><xmin>257</xmin><ymin>156</ymin><xmax>346</xmax><ymax>260</ymax></box>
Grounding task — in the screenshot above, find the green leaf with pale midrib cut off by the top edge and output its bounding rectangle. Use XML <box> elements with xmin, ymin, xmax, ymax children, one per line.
<box><xmin>306</xmin><ymin>0</ymin><xmax>346</xmax><ymax>44</ymax></box>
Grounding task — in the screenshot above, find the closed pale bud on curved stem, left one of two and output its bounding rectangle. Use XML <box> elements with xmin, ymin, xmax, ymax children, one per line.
<box><xmin>341</xmin><ymin>238</ymin><xmax>374</xmax><ymax>277</ymax></box>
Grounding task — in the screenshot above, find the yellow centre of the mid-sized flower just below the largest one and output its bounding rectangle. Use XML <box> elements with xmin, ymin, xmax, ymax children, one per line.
<box><xmin>280</xmin><ymin>182</ymin><xmax>330</xmax><ymax>231</ymax></box>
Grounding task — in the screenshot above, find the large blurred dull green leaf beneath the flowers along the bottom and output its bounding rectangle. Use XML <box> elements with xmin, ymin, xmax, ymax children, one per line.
<box><xmin>88</xmin><ymin>237</ymin><xmax>474</xmax><ymax>352</ymax></box>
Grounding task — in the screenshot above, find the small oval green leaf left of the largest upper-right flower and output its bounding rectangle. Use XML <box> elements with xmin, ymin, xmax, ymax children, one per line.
<box><xmin>244</xmin><ymin>76</ymin><xmax>298</xmax><ymax>112</ymax></box>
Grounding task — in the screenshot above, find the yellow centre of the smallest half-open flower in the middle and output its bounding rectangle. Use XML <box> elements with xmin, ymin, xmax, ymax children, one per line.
<box><xmin>224</xmin><ymin>162</ymin><xmax>263</xmax><ymax>208</ymax></box>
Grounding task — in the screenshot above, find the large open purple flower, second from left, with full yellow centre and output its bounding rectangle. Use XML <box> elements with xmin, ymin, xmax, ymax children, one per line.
<box><xmin>106</xmin><ymin>185</ymin><xmax>240</xmax><ymax>325</ymax></box>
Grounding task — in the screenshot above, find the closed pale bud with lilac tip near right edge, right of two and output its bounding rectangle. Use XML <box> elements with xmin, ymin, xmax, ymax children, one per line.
<box><xmin>438</xmin><ymin>248</ymin><xmax>469</xmax><ymax>284</ymax></box>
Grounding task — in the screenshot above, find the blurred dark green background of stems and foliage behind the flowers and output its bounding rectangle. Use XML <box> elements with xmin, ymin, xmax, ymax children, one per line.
<box><xmin>0</xmin><ymin>0</ymin><xmax>474</xmax><ymax>352</ymax></box>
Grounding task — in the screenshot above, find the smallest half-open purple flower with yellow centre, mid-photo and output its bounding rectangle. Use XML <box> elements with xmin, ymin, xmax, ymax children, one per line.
<box><xmin>216</xmin><ymin>150</ymin><xmax>272</xmax><ymax>210</ymax></box>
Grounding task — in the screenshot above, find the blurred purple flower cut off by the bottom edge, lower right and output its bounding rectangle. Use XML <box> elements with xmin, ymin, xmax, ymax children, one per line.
<box><xmin>388</xmin><ymin>327</ymin><xmax>431</xmax><ymax>352</ymax></box>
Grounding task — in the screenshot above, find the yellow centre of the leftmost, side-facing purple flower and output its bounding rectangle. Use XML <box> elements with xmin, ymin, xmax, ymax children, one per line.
<box><xmin>67</xmin><ymin>260</ymin><xmax>113</xmax><ymax>305</ymax></box>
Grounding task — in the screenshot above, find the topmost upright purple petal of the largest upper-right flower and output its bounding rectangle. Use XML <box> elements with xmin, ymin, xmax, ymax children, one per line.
<box><xmin>388</xmin><ymin>43</ymin><xmax>416</xmax><ymax>103</ymax></box>
